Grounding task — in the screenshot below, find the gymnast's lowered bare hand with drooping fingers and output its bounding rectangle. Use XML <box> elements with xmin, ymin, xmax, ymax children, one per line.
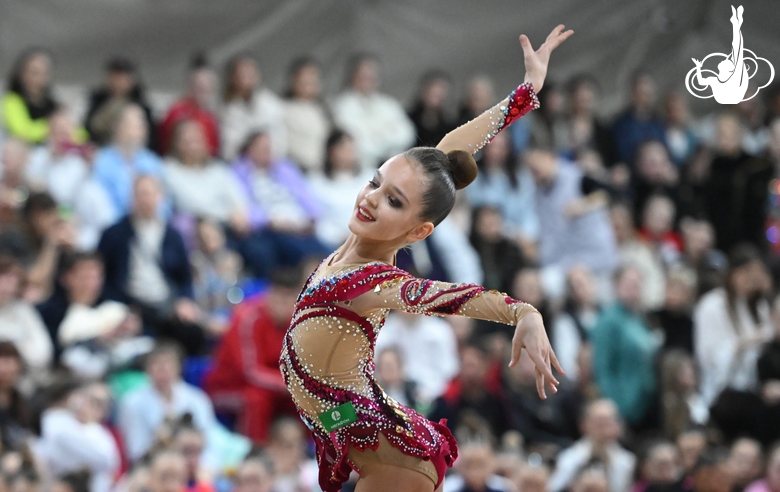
<box><xmin>509</xmin><ymin>312</ymin><xmax>565</xmax><ymax>399</ymax></box>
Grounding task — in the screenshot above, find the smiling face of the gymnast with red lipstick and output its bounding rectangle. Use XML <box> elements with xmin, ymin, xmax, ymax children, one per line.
<box><xmin>349</xmin><ymin>155</ymin><xmax>433</xmax><ymax>248</ymax></box>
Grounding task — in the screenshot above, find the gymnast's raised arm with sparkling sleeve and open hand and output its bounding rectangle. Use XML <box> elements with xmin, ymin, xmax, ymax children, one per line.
<box><xmin>436</xmin><ymin>24</ymin><xmax>574</xmax><ymax>154</ymax></box>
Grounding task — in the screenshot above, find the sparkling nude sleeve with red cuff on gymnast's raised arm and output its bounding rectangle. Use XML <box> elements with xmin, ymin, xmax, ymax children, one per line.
<box><xmin>436</xmin><ymin>82</ymin><xmax>539</xmax><ymax>154</ymax></box>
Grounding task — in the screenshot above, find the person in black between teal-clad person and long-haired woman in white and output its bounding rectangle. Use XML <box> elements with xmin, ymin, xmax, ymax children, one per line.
<box><xmin>650</xmin><ymin>267</ymin><xmax>696</xmax><ymax>355</ymax></box>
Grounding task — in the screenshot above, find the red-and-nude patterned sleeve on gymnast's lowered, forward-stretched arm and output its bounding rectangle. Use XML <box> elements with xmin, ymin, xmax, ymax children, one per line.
<box><xmin>353</xmin><ymin>265</ymin><xmax>538</xmax><ymax>326</ymax></box>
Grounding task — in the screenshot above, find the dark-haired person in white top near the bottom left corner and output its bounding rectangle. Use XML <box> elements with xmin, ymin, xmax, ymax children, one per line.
<box><xmin>33</xmin><ymin>381</ymin><xmax>120</xmax><ymax>492</ymax></box>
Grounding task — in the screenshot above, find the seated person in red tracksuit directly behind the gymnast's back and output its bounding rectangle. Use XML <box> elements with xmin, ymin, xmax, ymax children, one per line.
<box><xmin>205</xmin><ymin>267</ymin><xmax>303</xmax><ymax>444</ymax></box>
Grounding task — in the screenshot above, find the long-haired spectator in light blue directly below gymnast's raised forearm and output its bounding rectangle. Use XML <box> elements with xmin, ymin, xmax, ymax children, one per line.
<box><xmin>466</xmin><ymin>132</ymin><xmax>540</xmax><ymax>250</ymax></box>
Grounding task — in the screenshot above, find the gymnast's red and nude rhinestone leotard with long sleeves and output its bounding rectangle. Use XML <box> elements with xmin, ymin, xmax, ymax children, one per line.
<box><xmin>279</xmin><ymin>80</ymin><xmax>538</xmax><ymax>492</ymax></box>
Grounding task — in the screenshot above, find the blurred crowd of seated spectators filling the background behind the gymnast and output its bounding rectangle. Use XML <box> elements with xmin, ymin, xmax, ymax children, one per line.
<box><xmin>0</xmin><ymin>43</ymin><xmax>780</xmax><ymax>492</ymax></box>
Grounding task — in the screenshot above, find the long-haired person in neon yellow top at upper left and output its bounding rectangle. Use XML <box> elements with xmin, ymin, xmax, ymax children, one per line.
<box><xmin>0</xmin><ymin>48</ymin><xmax>58</xmax><ymax>145</ymax></box>
